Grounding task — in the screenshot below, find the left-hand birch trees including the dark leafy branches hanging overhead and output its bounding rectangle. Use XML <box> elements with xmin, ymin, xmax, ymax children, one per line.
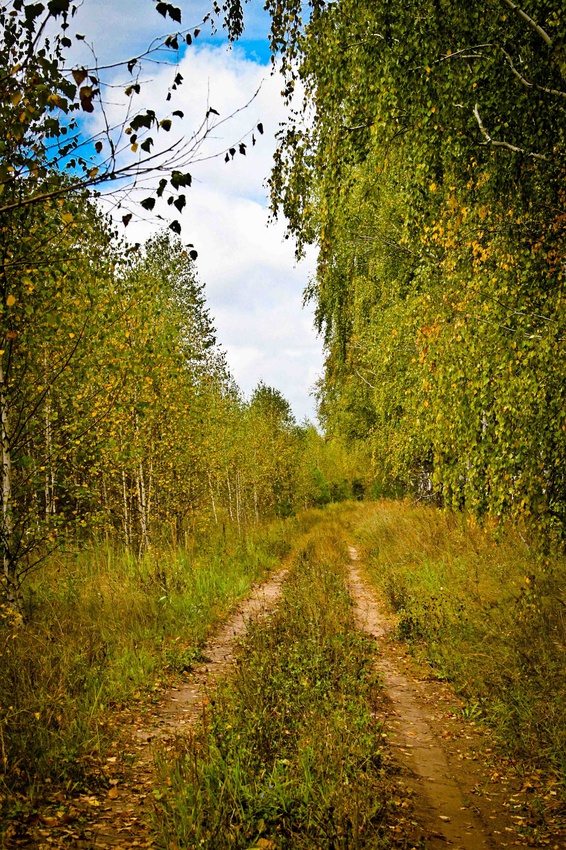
<box><xmin>0</xmin><ymin>0</ymin><xmax>372</xmax><ymax>609</ymax></box>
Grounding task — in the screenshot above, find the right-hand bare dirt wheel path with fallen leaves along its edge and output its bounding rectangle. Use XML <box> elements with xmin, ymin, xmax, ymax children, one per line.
<box><xmin>349</xmin><ymin>547</ymin><xmax>544</xmax><ymax>850</ymax></box>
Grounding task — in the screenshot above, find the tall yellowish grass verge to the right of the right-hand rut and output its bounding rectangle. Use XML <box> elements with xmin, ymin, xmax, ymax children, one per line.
<box><xmin>356</xmin><ymin>501</ymin><xmax>566</xmax><ymax>783</ymax></box>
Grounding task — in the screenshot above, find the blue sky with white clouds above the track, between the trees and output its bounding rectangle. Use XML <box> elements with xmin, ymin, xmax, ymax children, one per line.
<box><xmin>67</xmin><ymin>0</ymin><xmax>322</xmax><ymax>421</ymax></box>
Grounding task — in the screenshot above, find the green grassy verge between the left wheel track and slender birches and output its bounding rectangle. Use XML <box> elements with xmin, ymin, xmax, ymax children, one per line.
<box><xmin>0</xmin><ymin>521</ymin><xmax>295</xmax><ymax>815</ymax></box>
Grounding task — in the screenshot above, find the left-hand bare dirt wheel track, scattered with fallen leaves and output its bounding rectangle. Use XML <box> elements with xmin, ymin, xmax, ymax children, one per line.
<box><xmin>30</xmin><ymin>569</ymin><xmax>287</xmax><ymax>850</ymax></box>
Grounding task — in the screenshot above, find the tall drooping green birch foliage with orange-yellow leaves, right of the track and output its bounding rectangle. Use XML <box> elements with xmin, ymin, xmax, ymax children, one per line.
<box><xmin>271</xmin><ymin>0</ymin><xmax>566</xmax><ymax>539</ymax></box>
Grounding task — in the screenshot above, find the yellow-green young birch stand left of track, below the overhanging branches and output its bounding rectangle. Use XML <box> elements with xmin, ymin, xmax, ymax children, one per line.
<box><xmin>1</xmin><ymin>197</ymin><xmax>366</xmax><ymax>605</ymax></box>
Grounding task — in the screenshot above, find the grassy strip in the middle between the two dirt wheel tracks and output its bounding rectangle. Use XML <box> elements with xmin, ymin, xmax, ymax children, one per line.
<box><xmin>157</xmin><ymin>510</ymin><xmax>418</xmax><ymax>850</ymax></box>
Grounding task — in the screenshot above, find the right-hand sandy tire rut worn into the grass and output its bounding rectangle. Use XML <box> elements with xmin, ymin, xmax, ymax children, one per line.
<box><xmin>348</xmin><ymin>546</ymin><xmax>527</xmax><ymax>850</ymax></box>
